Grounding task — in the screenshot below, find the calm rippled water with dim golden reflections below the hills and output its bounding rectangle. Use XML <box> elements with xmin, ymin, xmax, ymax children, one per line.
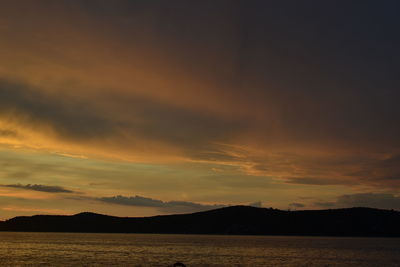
<box><xmin>0</xmin><ymin>232</ymin><xmax>400</xmax><ymax>267</ymax></box>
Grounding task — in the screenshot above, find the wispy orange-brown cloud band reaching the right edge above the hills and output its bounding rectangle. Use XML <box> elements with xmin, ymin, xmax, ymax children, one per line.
<box><xmin>210</xmin><ymin>146</ymin><xmax>400</xmax><ymax>188</ymax></box>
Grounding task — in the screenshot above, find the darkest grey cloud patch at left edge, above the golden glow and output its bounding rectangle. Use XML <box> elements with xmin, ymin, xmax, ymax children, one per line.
<box><xmin>0</xmin><ymin>79</ymin><xmax>115</xmax><ymax>139</ymax></box>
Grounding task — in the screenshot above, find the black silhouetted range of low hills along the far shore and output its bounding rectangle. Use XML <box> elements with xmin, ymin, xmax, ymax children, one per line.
<box><xmin>0</xmin><ymin>206</ymin><xmax>400</xmax><ymax>237</ymax></box>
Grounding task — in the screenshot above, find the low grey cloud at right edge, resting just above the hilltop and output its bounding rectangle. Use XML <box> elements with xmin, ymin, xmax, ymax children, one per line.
<box><xmin>315</xmin><ymin>193</ymin><xmax>400</xmax><ymax>210</ymax></box>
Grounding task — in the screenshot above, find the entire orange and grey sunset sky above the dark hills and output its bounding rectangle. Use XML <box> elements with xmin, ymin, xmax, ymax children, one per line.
<box><xmin>0</xmin><ymin>0</ymin><xmax>400</xmax><ymax>219</ymax></box>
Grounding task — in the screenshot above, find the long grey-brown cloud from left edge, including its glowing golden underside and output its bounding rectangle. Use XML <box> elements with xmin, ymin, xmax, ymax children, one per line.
<box><xmin>0</xmin><ymin>79</ymin><xmax>246</xmax><ymax>163</ymax></box>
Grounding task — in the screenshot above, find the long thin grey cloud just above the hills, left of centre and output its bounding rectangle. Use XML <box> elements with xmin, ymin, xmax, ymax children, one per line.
<box><xmin>97</xmin><ymin>196</ymin><xmax>225</xmax><ymax>212</ymax></box>
